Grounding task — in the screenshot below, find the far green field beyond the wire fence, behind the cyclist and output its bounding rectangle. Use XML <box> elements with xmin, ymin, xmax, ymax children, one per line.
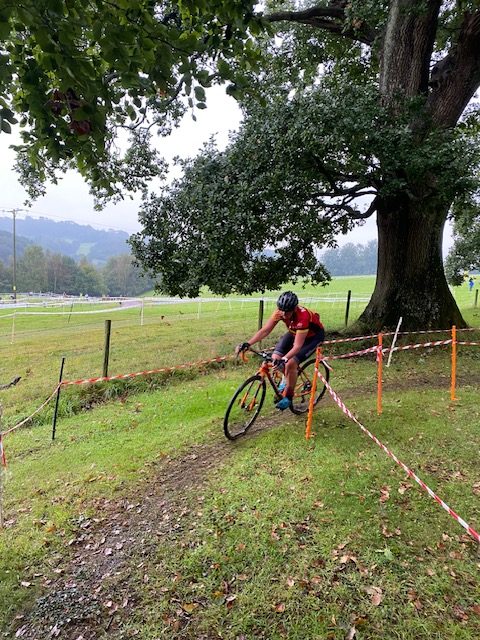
<box><xmin>0</xmin><ymin>276</ymin><xmax>480</xmax><ymax>426</ymax></box>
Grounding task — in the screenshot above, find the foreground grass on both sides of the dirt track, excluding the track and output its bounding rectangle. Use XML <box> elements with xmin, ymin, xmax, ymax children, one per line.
<box><xmin>0</xmin><ymin>282</ymin><xmax>480</xmax><ymax>640</ymax></box>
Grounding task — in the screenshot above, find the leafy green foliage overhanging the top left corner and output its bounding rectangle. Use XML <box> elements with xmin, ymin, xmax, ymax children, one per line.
<box><xmin>0</xmin><ymin>0</ymin><xmax>261</xmax><ymax>202</ymax></box>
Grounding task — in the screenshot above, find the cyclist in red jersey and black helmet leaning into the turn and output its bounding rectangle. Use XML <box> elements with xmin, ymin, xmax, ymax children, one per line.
<box><xmin>235</xmin><ymin>291</ymin><xmax>325</xmax><ymax>411</ymax></box>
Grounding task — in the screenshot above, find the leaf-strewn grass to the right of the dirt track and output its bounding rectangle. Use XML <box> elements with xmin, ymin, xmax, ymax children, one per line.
<box><xmin>121</xmin><ymin>372</ymin><xmax>480</xmax><ymax>640</ymax></box>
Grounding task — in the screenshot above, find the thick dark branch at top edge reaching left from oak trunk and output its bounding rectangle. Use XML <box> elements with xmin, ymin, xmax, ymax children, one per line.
<box><xmin>265</xmin><ymin>6</ymin><xmax>377</xmax><ymax>45</ymax></box>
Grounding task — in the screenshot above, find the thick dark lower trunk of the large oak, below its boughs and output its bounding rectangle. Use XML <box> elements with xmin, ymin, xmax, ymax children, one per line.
<box><xmin>357</xmin><ymin>198</ymin><xmax>466</xmax><ymax>331</ymax></box>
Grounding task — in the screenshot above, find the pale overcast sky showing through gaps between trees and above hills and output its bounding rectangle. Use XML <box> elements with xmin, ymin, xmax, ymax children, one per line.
<box><xmin>0</xmin><ymin>87</ymin><xmax>452</xmax><ymax>252</ymax></box>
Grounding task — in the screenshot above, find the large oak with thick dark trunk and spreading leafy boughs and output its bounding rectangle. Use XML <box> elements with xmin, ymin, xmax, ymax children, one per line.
<box><xmin>133</xmin><ymin>0</ymin><xmax>480</xmax><ymax>329</ymax></box>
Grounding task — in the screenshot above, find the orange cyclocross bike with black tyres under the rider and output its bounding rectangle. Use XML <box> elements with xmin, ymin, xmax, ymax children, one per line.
<box><xmin>223</xmin><ymin>347</ymin><xmax>330</xmax><ymax>440</ymax></box>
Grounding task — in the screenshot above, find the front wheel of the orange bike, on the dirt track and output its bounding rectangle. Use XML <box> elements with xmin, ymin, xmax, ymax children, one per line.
<box><xmin>223</xmin><ymin>375</ymin><xmax>267</xmax><ymax>440</ymax></box>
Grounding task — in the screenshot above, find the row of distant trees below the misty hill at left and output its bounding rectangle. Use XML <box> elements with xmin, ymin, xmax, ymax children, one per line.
<box><xmin>0</xmin><ymin>244</ymin><xmax>154</xmax><ymax>296</ymax></box>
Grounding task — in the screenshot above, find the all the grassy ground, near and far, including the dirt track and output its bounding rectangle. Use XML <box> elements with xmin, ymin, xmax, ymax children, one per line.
<box><xmin>0</xmin><ymin>279</ymin><xmax>480</xmax><ymax>640</ymax></box>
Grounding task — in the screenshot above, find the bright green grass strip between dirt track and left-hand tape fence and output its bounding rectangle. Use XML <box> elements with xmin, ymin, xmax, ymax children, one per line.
<box><xmin>0</xmin><ymin>371</ymin><xmax>233</xmax><ymax>628</ymax></box>
